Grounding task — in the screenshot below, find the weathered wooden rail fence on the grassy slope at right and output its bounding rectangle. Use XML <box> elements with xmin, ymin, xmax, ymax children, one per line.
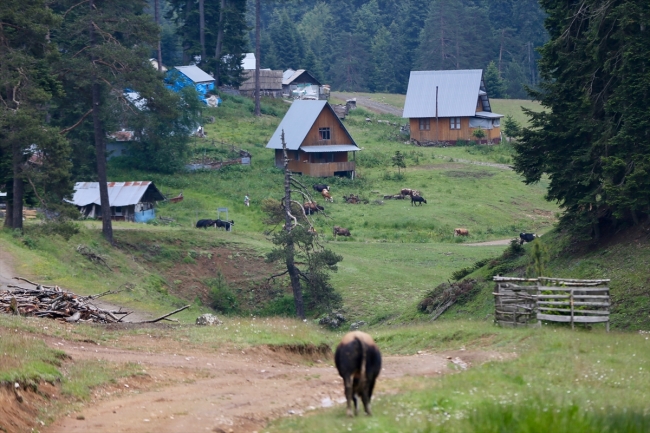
<box><xmin>494</xmin><ymin>277</ymin><xmax>611</xmax><ymax>332</ymax></box>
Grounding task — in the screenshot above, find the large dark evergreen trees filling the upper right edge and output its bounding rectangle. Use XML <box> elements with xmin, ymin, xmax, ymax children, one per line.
<box><xmin>515</xmin><ymin>0</ymin><xmax>650</xmax><ymax>238</ymax></box>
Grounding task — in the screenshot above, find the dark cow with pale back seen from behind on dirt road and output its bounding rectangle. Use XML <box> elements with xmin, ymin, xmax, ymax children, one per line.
<box><xmin>334</xmin><ymin>331</ymin><xmax>381</xmax><ymax>416</ymax></box>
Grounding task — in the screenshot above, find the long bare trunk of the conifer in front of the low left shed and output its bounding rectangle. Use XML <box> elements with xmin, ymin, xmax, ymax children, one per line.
<box><xmin>89</xmin><ymin>0</ymin><xmax>113</xmax><ymax>245</ymax></box>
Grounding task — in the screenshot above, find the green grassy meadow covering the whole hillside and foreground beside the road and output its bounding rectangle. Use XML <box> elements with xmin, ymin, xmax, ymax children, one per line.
<box><xmin>0</xmin><ymin>91</ymin><xmax>650</xmax><ymax>432</ymax></box>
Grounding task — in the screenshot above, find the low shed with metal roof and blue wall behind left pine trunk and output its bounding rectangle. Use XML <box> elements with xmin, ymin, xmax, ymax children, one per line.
<box><xmin>69</xmin><ymin>181</ymin><xmax>165</xmax><ymax>222</ymax></box>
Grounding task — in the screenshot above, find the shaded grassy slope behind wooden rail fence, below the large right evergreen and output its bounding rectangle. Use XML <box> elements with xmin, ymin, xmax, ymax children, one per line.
<box><xmin>442</xmin><ymin>227</ymin><xmax>650</xmax><ymax>330</ymax></box>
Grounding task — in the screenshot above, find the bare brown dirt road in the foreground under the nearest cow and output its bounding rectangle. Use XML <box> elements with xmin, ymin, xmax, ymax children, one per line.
<box><xmin>44</xmin><ymin>330</ymin><xmax>504</xmax><ymax>433</ymax></box>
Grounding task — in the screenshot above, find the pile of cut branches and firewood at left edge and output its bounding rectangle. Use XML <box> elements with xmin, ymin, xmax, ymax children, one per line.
<box><xmin>0</xmin><ymin>277</ymin><xmax>189</xmax><ymax>323</ymax></box>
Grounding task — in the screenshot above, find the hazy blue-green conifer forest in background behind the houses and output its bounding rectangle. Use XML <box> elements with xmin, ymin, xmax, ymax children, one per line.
<box><xmin>254</xmin><ymin>0</ymin><xmax>546</xmax><ymax>98</ymax></box>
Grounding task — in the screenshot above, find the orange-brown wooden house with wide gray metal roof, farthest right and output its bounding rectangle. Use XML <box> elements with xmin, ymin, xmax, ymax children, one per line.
<box><xmin>403</xmin><ymin>69</ymin><xmax>503</xmax><ymax>145</ymax></box>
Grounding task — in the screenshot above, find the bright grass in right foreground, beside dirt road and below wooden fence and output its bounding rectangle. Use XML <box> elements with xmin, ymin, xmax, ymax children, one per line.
<box><xmin>268</xmin><ymin>321</ymin><xmax>650</xmax><ymax>432</ymax></box>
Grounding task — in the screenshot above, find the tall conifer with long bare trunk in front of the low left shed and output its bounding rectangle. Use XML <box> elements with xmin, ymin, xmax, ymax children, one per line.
<box><xmin>53</xmin><ymin>0</ymin><xmax>162</xmax><ymax>243</ymax></box>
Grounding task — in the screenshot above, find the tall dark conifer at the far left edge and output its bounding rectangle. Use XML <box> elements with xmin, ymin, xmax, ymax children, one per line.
<box><xmin>0</xmin><ymin>0</ymin><xmax>71</xmax><ymax>230</ymax></box>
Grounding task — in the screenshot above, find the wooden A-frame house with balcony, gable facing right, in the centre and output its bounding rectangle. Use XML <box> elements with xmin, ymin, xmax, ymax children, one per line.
<box><xmin>266</xmin><ymin>100</ymin><xmax>361</xmax><ymax>178</ymax></box>
